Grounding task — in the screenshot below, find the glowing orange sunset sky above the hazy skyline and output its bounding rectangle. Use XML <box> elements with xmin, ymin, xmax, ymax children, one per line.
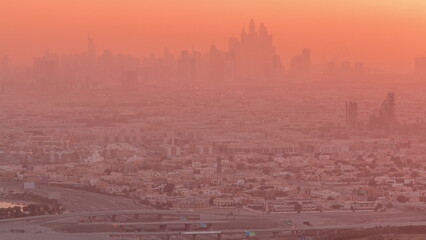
<box><xmin>0</xmin><ymin>0</ymin><xmax>426</xmax><ymax>71</ymax></box>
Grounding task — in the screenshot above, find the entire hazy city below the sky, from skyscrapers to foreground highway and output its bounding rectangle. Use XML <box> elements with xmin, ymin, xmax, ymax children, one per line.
<box><xmin>0</xmin><ymin>0</ymin><xmax>426</xmax><ymax>240</ymax></box>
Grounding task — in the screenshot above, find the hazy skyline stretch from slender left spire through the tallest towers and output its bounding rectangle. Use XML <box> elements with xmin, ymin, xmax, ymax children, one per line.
<box><xmin>25</xmin><ymin>20</ymin><xmax>284</xmax><ymax>90</ymax></box>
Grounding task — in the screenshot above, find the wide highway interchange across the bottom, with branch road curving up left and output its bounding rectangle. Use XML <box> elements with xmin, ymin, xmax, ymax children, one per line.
<box><xmin>0</xmin><ymin>186</ymin><xmax>426</xmax><ymax>240</ymax></box>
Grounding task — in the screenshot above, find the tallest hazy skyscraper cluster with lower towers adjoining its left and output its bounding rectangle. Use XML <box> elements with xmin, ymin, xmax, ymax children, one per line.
<box><xmin>171</xmin><ymin>20</ymin><xmax>282</xmax><ymax>86</ymax></box>
